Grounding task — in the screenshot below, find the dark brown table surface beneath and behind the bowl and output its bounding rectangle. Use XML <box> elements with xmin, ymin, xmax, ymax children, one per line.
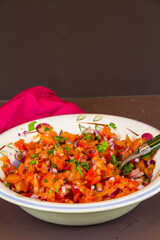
<box><xmin>0</xmin><ymin>95</ymin><xmax>160</xmax><ymax>240</ymax></box>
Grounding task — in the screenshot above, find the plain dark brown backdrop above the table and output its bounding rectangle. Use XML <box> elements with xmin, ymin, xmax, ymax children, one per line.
<box><xmin>0</xmin><ymin>0</ymin><xmax>160</xmax><ymax>99</ymax></box>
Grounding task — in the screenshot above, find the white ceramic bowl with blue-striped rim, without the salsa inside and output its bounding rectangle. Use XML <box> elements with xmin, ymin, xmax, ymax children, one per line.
<box><xmin>0</xmin><ymin>114</ymin><xmax>160</xmax><ymax>226</ymax></box>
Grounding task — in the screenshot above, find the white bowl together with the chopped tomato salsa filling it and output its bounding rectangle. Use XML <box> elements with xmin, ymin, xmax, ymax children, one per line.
<box><xmin>0</xmin><ymin>114</ymin><xmax>160</xmax><ymax>225</ymax></box>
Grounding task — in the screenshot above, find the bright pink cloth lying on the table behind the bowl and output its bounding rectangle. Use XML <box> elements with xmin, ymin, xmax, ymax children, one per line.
<box><xmin>0</xmin><ymin>86</ymin><xmax>84</xmax><ymax>133</ymax></box>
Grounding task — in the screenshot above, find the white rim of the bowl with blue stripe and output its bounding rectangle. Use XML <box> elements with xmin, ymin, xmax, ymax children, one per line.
<box><xmin>0</xmin><ymin>113</ymin><xmax>160</xmax><ymax>213</ymax></box>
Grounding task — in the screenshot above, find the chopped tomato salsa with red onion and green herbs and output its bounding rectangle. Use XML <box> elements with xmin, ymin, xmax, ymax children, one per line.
<box><xmin>0</xmin><ymin>123</ymin><xmax>155</xmax><ymax>203</ymax></box>
